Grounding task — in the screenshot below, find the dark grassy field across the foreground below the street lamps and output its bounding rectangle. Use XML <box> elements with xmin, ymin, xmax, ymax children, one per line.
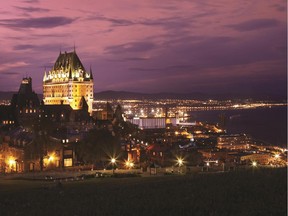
<box><xmin>0</xmin><ymin>169</ymin><xmax>287</xmax><ymax>216</ymax></box>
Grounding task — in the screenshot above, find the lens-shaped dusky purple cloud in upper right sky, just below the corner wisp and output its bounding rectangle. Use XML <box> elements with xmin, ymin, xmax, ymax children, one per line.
<box><xmin>227</xmin><ymin>19</ymin><xmax>280</xmax><ymax>31</ymax></box>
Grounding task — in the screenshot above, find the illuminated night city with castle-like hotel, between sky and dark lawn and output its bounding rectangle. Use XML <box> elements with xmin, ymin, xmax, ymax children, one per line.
<box><xmin>0</xmin><ymin>50</ymin><xmax>287</xmax><ymax>174</ymax></box>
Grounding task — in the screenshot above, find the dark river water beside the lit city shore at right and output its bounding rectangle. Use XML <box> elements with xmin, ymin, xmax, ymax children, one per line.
<box><xmin>191</xmin><ymin>106</ymin><xmax>287</xmax><ymax>146</ymax></box>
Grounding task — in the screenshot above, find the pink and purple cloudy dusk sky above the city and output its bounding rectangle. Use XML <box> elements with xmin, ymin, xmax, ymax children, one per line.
<box><xmin>0</xmin><ymin>0</ymin><xmax>287</xmax><ymax>95</ymax></box>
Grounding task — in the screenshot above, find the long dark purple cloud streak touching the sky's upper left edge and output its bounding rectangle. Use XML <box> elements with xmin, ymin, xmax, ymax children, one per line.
<box><xmin>0</xmin><ymin>17</ymin><xmax>77</xmax><ymax>28</ymax></box>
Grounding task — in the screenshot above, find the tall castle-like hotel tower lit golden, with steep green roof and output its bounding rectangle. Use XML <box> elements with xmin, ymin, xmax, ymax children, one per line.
<box><xmin>43</xmin><ymin>50</ymin><xmax>93</xmax><ymax>113</ymax></box>
